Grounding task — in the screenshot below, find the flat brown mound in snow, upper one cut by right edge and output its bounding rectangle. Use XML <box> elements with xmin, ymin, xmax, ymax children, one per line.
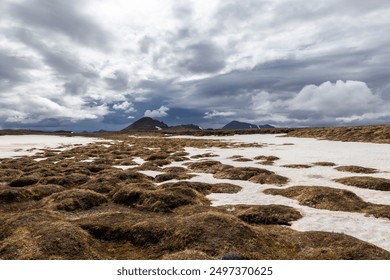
<box><xmin>334</xmin><ymin>176</ymin><xmax>390</xmax><ymax>191</ymax></box>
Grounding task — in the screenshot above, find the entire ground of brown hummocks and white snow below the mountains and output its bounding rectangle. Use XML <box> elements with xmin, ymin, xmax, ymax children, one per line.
<box><xmin>0</xmin><ymin>126</ymin><xmax>390</xmax><ymax>259</ymax></box>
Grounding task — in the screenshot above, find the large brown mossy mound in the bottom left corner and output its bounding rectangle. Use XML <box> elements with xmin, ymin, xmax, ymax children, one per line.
<box><xmin>0</xmin><ymin>210</ymin><xmax>106</xmax><ymax>260</ymax></box>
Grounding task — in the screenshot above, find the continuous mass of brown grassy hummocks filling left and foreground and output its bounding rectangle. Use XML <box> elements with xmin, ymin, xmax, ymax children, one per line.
<box><xmin>0</xmin><ymin>130</ymin><xmax>390</xmax><ymax>259</ymax></box>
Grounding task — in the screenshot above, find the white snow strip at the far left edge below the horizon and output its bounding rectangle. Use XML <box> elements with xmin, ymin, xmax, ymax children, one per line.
<box><xmin>0</xmin><ymin>135</ymin><xmax>100</xmax><ymax>158</ymax></box>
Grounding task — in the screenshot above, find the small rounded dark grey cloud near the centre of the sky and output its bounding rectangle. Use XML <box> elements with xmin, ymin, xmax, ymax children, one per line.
<box><xmin>177</xmin><ymin>41</ymin><xmax>226</xmax><ymax>74</ymax></box>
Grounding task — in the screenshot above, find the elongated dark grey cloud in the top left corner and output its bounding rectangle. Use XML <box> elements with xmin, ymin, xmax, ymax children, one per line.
<box><xmin>7</xmin><ymin>0</ymin><xmax>110</xmax><ymax>50</ymax></box>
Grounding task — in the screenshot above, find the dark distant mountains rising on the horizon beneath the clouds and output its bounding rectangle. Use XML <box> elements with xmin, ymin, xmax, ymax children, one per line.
<box><xmin>122</xmin><ymin>117</ymin><xmax>274</xmax><ymax>131</ymax></box>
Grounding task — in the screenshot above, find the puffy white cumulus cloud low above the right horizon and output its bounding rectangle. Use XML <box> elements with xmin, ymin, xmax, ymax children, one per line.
<box><xmin>288</xmin><ymin>81</ymin><xmax>382</xmax><ymax>117</ymax></box>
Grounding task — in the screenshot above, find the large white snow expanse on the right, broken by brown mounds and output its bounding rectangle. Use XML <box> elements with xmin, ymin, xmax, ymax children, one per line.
<box><xmin>169</xmin><ymin>134</ymin><xmax>390</xmax><ymax>251</ymax></box>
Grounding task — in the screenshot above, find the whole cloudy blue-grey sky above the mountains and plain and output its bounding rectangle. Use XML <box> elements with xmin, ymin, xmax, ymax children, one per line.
<box><xmin>0</xmin><ymin>0</ymin><xmax>390</xmax><ymax>131</ymax></box>
